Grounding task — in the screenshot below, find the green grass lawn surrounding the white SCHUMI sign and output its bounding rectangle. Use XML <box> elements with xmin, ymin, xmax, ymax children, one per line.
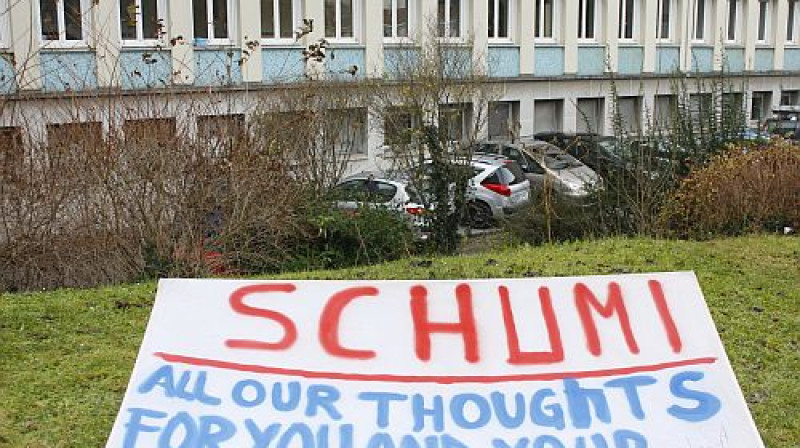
<box><xmin>0</xmin><ymin>236</ymin><xmax>800</xmax><ymax>448</ymax></box>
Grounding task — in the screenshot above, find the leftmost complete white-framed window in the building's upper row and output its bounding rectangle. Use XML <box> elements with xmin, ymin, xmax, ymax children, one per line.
<box><xmin>39</xmin><ymin>0</ymin><xmax>89</xmax><ymax>43</ymax></box>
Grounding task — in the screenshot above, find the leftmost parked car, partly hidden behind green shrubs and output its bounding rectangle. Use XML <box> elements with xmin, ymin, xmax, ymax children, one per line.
<box><xmin>331</xmin><ymin>172</ymin><xmax>427</xmax><ymax>230</ymax></box>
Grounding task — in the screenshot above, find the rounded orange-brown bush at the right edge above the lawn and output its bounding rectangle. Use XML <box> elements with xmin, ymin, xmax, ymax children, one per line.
<box><xmin>662</xmin><ymin>140</ymin><xmax>800</xmax><ymax>238</ymax></box>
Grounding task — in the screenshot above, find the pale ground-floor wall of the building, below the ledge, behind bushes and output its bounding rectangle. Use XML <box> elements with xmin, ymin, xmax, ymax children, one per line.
<box><xmin>0</xmin><ymin>75</ymin><xmax>800</xmax><ymax>177</ymax></box>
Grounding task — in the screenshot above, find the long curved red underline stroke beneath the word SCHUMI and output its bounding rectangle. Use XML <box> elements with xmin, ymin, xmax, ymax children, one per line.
<box><xmin>153</xmin><ymin>352</ymin><xmax>717</xmax><ymax>384</ymax></box>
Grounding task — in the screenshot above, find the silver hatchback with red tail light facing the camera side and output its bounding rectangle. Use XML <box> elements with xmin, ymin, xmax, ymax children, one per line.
<box><xmin>412</xmin><ymin>154</ymin><xmax>530</xmax><ymax>229</ymax></box>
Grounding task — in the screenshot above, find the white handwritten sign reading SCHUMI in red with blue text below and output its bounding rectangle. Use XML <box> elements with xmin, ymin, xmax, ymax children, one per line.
<box><xmin>107</xmin><ymin>273</ymin><xmax>763</xmax><ymax>448</ymax></box>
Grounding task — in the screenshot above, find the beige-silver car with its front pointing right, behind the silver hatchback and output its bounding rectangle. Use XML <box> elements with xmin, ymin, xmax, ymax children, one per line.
<box><xmin>479</xmin><ymin>140</ymin><xmax>603</xmax><ymax>199</ymax></box>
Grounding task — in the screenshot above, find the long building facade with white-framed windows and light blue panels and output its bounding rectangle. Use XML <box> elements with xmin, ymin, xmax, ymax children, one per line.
<box><xmin>0</xmin><ymin>0</ymin><xmax>800</xmax><ymax>172</ymax></box>
